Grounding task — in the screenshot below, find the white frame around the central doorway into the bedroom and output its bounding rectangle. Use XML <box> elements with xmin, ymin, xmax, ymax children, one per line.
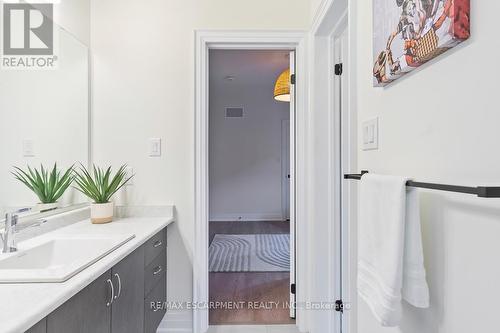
<box><xmin>193</xmin><ymin>30</ymin><xmax>308</xmax><ymax>333</ymax></box>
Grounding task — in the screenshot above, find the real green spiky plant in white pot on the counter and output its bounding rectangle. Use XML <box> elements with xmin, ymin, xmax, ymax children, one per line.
<box><xmin>75</xmin><ymin>165</ymin><xmax>133</xmax><ymax>224</ymax></box>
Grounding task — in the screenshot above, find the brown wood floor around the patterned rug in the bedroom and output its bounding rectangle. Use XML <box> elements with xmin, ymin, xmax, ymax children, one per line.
<box><xmin>209</xmin><ymin>221</ymin><xmax>295</xmax><ymax>325</ymax></box>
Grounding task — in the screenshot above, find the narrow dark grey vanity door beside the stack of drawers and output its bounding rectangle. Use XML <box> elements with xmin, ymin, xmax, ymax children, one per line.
<box><xmin>111</xmin><ymin>247</ymin><xmax>144</xmax><ymax>333</ymax></box>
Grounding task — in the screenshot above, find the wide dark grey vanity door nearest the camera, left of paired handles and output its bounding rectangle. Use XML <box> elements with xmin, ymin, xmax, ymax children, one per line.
<box><xmin>47</xmin><ymin>271</ymin><xmax>111</xmax><ymax>333</ymax></box>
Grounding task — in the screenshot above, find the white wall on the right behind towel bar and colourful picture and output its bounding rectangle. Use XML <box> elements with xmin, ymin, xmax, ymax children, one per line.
<box><xmin>351</xmin><ymin>1</ymin><xmax>500</xmax><ymax>333</ymax></box>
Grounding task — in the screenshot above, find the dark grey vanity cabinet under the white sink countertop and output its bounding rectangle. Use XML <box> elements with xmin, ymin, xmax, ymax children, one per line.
<box><xmin>27</xmin><ymin>230</ymin><xmax>167</xmax><ymax>333</ymax></box>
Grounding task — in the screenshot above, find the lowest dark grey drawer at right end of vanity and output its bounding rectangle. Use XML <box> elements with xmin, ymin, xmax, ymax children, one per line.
<box><xmin>144</xmin><ymin>274</ymin><xmax>167</xmax><ymax>333</ymax></box>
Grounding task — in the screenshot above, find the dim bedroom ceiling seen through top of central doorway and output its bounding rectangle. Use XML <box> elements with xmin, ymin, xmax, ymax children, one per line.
<box><xmin>209</xmin><ymin>50</ymin><xmax>290</xmax><ymax>87</ymax></box>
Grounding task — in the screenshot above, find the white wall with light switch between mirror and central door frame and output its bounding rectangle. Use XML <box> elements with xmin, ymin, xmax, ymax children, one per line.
<box><xmin>91</xmin><ymin>0</ymin><xmax>309</xmax><ymax>326</ymax></box>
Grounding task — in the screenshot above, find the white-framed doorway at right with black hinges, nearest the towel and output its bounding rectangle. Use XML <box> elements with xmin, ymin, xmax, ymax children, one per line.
<box><xmin>307</xmin><ymin>1</ymin><xmax>357</xmax><ymax>333</ymax></box>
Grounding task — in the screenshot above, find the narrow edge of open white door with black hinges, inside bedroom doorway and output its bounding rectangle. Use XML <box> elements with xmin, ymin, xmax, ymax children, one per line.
<box><xmin>289</xmin><ymin>51</ymin><xmax>296</xmax><ymax>318</ymax></box>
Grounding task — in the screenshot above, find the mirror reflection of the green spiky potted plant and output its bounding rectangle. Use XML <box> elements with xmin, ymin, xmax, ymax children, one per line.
<box><xmin>12</xmin><ymin>163</ymin><xmax>74</xmax><ymax>212</ymax></box>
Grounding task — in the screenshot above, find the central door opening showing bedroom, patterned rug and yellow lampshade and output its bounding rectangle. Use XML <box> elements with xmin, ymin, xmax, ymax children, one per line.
<box><xmin>208</xmin><ymin>49</ymin><xmax>295</xmax><ymax>325</ymax></box>
